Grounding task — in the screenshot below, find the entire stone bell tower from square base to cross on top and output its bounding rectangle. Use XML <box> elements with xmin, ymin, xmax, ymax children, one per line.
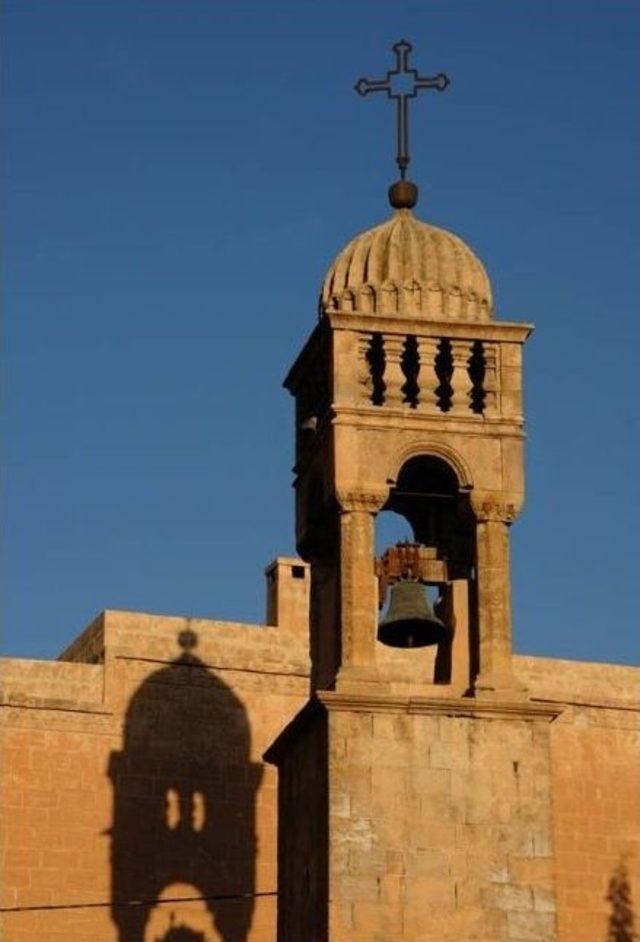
<box><xmin>266</xmin><ymin>42</ymin><xmax>559</xmax><ymax>942</ymax></box>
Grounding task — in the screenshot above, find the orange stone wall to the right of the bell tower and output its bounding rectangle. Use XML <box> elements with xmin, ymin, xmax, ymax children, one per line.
<box><xmin>516</xmin><ymin>657</ymin><xmax>640</xmax><ymax>942</ymax></box>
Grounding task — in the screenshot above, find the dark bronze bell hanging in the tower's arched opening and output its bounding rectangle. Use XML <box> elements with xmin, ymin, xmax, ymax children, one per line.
<box><xmin>378</xmin><ymin>580</ymin><xmax>449</xmax><ymax>648</ymax></box>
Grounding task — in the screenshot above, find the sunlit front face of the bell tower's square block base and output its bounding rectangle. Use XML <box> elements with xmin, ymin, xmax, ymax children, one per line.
<box><xmin>320</xmin><ymin>702</ymin><xmax>555</xmax><ymax>942</ymax></box>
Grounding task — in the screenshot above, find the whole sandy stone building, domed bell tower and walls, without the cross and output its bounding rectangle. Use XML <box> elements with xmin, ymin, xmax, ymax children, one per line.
<box><xmin>2</xmin><ymin>195</ymin><xmax>640</xmax><ymax>942</ymax></box>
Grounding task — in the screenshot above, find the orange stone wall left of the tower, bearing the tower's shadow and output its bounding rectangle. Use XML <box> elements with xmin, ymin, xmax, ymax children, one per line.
<box><xmin>2</xmin><ymin>613</ymin><xmax>308</xmax><ymax>942</ymax></box>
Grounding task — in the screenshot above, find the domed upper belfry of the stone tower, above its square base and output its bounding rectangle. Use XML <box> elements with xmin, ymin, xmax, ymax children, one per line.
<box><xmin>285</xmin><ymin>181</ymin><xmax>532</xmax><ymax>696</ymax></box>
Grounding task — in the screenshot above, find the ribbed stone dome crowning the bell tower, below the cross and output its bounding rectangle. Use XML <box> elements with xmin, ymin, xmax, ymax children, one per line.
<box><xmin>321</xmin><ymin>209</ymin><xmax>493</xmax><ymax>321</ymax></box>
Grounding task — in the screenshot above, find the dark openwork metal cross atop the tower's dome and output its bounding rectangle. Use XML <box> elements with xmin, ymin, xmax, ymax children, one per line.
<box><xmin>355</xmin><ymin>39</ymin><xmax>449</xmax><ymax>180</ymax></box>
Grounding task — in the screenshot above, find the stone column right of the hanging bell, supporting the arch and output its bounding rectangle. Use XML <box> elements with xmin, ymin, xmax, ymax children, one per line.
<box><xmin>472</xmin><ymin>500</ymin><xmax>524</xmax><ymax>697</ymax></box>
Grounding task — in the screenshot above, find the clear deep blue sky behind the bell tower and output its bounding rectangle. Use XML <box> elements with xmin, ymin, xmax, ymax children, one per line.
<box><xmin>3</xmin><ymin>0</ymin><xmax>640</xmax><ymax>662</ymax></box>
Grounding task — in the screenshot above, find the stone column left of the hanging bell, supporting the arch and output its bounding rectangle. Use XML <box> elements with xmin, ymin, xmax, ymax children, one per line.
<box><xmin>338</xmin><ymin>492</ymin><xmax>386</xmax><ymax>687</ymax></box>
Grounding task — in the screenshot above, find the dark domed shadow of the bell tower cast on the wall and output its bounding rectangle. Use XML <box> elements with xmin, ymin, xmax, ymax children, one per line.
<box><xmin>109</xmin><ymin>631</ymin><xmax>262</xmax><ymax>942</ymax></box>
